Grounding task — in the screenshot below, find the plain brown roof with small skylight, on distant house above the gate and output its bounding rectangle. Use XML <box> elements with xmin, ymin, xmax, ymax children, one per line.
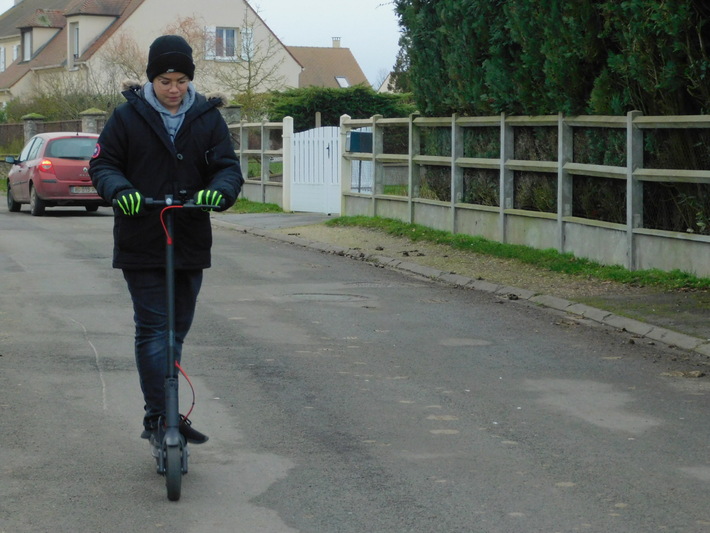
<box><xmin>287</xmin><ymin>46</ymin><xmax>368</xmax><ymax>88</ymax></box>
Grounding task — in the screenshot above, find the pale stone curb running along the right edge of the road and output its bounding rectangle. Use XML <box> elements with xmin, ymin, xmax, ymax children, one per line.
<box><xmin>212</xmin><ymin>217</ymin><xmax>710</xmax><ymax>358</ymax></box>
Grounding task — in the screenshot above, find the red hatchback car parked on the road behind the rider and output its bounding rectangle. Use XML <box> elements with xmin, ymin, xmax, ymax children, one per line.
<box><xmin>5</xmin><ymin>132</ymin><xmax>108</xmax><ymax>216</ymax></box>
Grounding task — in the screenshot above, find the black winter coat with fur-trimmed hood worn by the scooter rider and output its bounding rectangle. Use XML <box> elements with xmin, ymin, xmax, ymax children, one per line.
<box><xmin>89</xmin><ymin>84</ymin><xmax>244</xmax><ymax>269</ymax></box>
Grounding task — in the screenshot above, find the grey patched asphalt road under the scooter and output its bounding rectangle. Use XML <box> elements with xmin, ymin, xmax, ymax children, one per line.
<box><xmin>0</xmin><ymin>209</ymin><xmax>710</xmax><ymax>533</ymax></box>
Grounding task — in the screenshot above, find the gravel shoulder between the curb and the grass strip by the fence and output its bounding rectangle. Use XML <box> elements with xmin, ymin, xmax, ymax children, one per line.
<box><xmin>273</xmin><ymin>224</ymin><xmax>710</xmax><ymax>339</ymax></box>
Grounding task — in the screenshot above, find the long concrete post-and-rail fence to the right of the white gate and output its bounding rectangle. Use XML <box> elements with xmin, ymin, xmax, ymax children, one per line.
<box><xmin>340</xmin><ymin>112</ymin><xmax>710</xmax><ymax>276</ymax></box>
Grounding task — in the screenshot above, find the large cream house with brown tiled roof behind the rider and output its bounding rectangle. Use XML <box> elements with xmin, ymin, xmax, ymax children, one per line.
<box><xmin>0</xmin><ymin>0</ymin><xmax>303</xmax><ymax>102</ymax></box>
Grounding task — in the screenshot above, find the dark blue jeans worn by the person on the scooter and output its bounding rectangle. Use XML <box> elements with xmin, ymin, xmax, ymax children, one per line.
<box><xmin>123</xmin><ymin>269</ymin><xmax>202</xmax><ymax>429</ymax></box>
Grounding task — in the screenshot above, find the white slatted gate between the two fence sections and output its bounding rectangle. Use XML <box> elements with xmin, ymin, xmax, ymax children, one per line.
<box><xmin>290</xmin><ymin>127</ymin><xmax>341</xmax><ymax>214</ymax></box>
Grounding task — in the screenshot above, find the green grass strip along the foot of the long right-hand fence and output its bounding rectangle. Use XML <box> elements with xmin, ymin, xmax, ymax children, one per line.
<box><xmin>326</xmin><ymin>216</ymin><xmax>710</xmax><ymax>290</ymax></box>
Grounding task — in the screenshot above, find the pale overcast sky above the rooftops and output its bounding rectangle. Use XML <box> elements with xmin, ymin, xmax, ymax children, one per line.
<box><xmin>0</xmin><ymin>0</ymin><xmax>399</xmax><ymax>88</ymax></box>
